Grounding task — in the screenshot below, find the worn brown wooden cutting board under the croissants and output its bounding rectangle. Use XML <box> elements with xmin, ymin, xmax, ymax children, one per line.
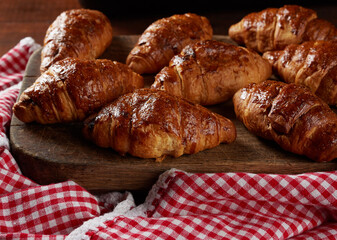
<box><xmin>10</xmin><ymin>35</ymin><xmax>337</xmax><ymax>192</ymax></box>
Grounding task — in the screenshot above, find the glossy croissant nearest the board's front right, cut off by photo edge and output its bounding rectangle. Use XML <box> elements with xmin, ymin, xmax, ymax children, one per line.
<box><xmin>233</xmin><ymin>80</ymin><xmax>337</xmax><ymax>162</ymax></box>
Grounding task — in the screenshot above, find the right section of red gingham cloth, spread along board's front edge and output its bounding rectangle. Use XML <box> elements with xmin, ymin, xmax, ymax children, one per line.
<box><xmin>70</xmin><ymin>170</ymin><xmax>337</xmax><ymax>240</ymax></box>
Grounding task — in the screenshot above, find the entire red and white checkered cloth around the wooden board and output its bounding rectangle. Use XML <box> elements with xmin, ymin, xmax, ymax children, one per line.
<box><xmin>0</xmin><ymin>38</ymin><xmax>337</xmax><ymax>240</ymax></box>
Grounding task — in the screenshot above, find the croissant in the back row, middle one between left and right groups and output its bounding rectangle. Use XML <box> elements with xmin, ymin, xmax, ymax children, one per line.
<box><xmin>126</xmin><ymin>13</ymin><xmax>213</xmax><ymax>74</ymax></box>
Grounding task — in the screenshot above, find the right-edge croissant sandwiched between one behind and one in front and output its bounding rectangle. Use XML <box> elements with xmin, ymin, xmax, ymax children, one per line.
<box><xmin>263</xmin><ymin>40</ymin><xmax>337</xmax><ymax>105</ymax></box>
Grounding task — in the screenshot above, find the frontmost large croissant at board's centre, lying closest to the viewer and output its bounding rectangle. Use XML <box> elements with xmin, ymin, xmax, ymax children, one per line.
<box><xmin>83</xmin><ymin>88</ymin><xmax>236</xmax><ymax>160</ymax></box>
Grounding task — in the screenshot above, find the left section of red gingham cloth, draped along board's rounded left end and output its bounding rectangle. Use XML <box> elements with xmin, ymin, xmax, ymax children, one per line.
<box><xmin>0</xmin><ymin>38</ymin><xmax>107</xmax><ymax>239</ymax></box>
